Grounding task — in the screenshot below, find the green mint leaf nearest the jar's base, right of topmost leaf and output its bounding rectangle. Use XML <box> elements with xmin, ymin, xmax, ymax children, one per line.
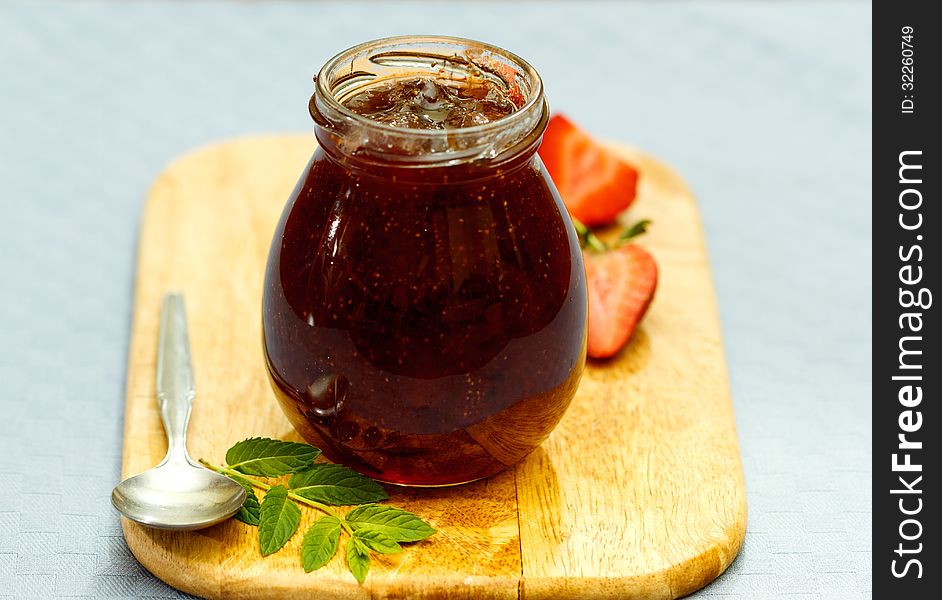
<box><xmin>288</xmin><ymin>464</ymin><xmax>389</xmax><ymax>506</ymax></box>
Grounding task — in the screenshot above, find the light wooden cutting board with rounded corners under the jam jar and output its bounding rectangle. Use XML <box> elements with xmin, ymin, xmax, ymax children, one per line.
<box><xmin>122</xmin><ymin>136</ymin><xmax>746</xmax><ymax>599</ymax></box>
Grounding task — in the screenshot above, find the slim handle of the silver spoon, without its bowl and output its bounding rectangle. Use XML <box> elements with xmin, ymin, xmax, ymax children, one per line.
<box><xmin>157</xmin><ymin>293</ymin><xmax>196</xmax><ymax>462</ymax></box>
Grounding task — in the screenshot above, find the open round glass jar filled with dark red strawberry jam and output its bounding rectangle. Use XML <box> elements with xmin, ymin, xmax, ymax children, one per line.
<box><xmin>263</xmin><ymin>37</ymin><xmax>586</xmax><ymax>486</ymax></box>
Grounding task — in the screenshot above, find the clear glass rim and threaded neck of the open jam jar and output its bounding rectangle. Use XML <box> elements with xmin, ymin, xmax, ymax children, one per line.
<box><xmin>309</xmin><ymin>36</ymin><xmax>549</xmax><ymax>167</ymax></box>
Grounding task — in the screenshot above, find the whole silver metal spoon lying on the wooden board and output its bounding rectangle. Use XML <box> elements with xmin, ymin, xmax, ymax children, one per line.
<box><xmin>111</xmin><ymin>294</ymin><xmax>245</xmax><ymax>530</ymax></box>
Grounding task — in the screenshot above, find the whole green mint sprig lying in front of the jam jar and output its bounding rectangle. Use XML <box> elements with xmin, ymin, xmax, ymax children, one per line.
<box><xmin>200</xmin><ymin>438</ymin><xmax>436</xmax><ymax>583</ymax></box>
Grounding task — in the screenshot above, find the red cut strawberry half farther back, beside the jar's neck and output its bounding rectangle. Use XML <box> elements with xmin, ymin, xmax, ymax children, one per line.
<box><xmin>539</xmin><ymin>114</ymin><xmax>638</xmax><ymax>226</ymax></box>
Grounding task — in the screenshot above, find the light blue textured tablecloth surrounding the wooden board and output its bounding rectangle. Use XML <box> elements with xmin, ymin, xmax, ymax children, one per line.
<box><xmin>0</xmin><ymin>2</ymin><xmax>872</xmax><ymax>600</ymax></box>
